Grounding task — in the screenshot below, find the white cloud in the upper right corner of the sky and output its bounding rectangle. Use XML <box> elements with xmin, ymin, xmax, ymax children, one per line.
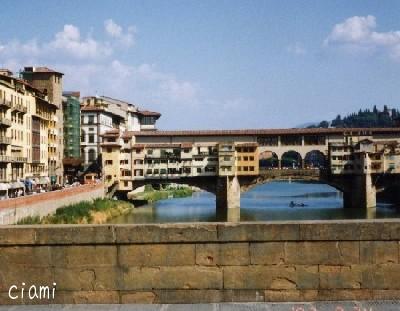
<box><xmin>324</xmin><ymin>15</ymin><xmax>400</xmax><ymax>61</ymax></box>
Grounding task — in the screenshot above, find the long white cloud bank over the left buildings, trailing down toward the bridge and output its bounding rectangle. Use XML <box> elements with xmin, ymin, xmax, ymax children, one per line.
<box><xmin>0</xmin><ymin>20</ymin><xmax>242</xmax><ymax>128</ymax></box>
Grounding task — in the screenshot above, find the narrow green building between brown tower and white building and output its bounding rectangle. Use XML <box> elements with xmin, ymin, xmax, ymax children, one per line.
<box><xmin>63</xmin><ymin>92</ymin><xmax>82</xmax><ymax>183</ymax></box>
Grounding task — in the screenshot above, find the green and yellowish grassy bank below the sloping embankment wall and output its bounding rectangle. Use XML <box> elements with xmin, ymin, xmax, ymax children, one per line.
<box><xmin>18</xmin><ymin>199</ymin><xmax>133</xmax><ymax>225</ymax></box>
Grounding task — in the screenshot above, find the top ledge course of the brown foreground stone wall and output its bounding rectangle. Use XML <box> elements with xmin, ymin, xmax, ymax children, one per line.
<box><xmin>0</xmin><ymin>219</ymin><xmax>400</xmax><ymax>245</ymax></box>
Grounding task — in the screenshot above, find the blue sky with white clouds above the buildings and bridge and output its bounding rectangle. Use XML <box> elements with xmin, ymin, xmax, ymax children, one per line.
<box><xmin>0</xmin><ymin>0</ymin><xmax>400</xmax><ymax>129</ymax></box>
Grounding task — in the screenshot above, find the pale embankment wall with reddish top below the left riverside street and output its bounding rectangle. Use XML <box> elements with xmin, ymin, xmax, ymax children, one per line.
<box><xmin>0</xmin><ymin>183</ymin><xmax>105</xmax><ymax>225</ymax></box>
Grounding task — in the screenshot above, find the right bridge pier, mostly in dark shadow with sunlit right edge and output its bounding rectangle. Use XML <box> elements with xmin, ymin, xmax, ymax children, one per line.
<box><xmin>343</xmin><ymin>173</ymin><xmax>376</xmax><ymax>209</ymax></box>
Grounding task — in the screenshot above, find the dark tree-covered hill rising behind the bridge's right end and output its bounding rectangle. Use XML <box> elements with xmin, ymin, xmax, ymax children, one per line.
<box><xmin>309</xmin><ymin>105</ymin><xmax>400</xmax><ymax>128</ymax></box>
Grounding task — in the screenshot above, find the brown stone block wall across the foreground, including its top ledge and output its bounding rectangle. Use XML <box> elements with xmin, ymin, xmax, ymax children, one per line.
<box><xmin>0</xmin><ymin>220</ymin><xmax>400</xmax><ymax>304</ymax></box>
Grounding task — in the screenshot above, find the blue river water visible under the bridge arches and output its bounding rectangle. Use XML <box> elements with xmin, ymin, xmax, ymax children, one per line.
<box><xmin>110</xmin><ymin>181</ymin><xmax>400</xmax><ymax>223</ymax></box>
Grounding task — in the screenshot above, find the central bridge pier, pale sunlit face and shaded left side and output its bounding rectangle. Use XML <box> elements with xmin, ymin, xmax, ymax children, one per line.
<box><xmin>216</xmin><ymin>176</ymin><xmax>240</xmax><ymax>221</ymax></box>
